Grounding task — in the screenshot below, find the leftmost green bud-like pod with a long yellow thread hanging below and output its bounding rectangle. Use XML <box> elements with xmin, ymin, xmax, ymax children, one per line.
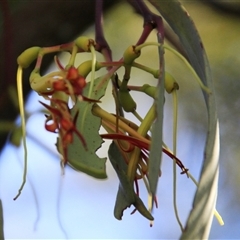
<box><xmin>17</xmin><ymin>47</ymin><xmax>41</xmax><ymax>68</ymax></box>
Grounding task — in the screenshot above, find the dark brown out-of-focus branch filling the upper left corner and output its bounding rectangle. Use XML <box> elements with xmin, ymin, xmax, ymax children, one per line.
<box><xmin>0</xmin><ymin>0</ymin><xmax>118</xmax><ymax>151</ymax></box>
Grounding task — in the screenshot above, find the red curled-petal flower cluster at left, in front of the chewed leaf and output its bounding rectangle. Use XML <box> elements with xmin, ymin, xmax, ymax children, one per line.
<box><xmin>35</xmin><ymin>60</ymin><xmax>87</xmax><ymax>165</ymax></box>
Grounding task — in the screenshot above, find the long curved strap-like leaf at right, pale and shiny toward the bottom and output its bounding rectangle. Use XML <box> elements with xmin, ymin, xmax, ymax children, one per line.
<box><xmin>149</xmin><ymin>0</ymin><xmax>219</xmax><ymax>239</ymax></box>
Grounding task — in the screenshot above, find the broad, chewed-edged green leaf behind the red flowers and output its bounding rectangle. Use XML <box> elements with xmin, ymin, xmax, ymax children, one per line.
<box><xmin>68</xmin><ymin>77</ymin><xmax>110</xmax><ymax>178</ymax></box>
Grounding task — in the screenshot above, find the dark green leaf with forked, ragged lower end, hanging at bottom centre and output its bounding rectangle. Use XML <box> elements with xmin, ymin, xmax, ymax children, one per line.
<box><xmin>108</xmin><ymin>142</ymin><xmax>153</xmax><ymax>220</ymax></box>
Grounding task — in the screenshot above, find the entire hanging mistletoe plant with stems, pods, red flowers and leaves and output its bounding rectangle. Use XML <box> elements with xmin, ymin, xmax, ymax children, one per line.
<box><xmin>14</xmin><ymin>0</ymin><xmax>223</xmax><ymax>238</ymax></box>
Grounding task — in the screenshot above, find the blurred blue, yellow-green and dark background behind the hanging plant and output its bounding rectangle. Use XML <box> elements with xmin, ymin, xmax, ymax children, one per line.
<box><xmin>0</xmin><ymin>1</ymin><xmax>240</xmax><ymax>239</ymax></box>
